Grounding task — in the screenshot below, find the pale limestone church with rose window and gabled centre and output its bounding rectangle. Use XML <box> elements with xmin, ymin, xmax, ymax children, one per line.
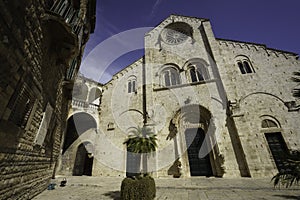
<box><xmin>60</xmin><ymin>15</ymin><xmax>300</xmax><ymax>177</ymax></box>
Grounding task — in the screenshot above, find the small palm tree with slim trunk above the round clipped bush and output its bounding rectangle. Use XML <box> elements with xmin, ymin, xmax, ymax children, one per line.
<box><xmin>123</xmin><ymin>126</ymin><xmax>157</xmax><ymax>174</ymax></box>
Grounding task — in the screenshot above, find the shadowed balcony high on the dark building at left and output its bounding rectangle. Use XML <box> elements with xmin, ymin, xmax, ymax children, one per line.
<box><xmin>42</xmin><ymin>0</ymin><xmax>85</xmax><ymax>65</ymax></box>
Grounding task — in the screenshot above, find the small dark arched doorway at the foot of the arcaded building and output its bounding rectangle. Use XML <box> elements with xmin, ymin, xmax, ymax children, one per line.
<box><xmin>73</xmin><ymin>143</ymin><xmax>94</xmax><ymax>176</ymax></box>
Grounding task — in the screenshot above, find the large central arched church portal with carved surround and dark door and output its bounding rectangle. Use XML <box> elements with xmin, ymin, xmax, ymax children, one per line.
<box><xmin>169</xmin><ymin>105</ymin><xmax>220</xmax><ymax>177</ymax></box>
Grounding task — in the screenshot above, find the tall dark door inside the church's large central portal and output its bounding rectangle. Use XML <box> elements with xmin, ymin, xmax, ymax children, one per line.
<box><xmin>185</xmin><ymin>128</ymin><xmax>213</xmax><ymax>176</ymax></box>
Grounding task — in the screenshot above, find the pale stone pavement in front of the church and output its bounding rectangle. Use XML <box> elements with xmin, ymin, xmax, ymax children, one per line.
<box><xmin>34</xmin><ymin>176</ymin><xmax>300</xmax><ymax>200</ymax></box>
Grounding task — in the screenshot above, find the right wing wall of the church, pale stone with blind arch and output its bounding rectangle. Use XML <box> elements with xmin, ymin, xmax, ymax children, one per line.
<box><xmin>215</xmin><ymin>40</ymin><xmax>300</xmax><ymax>177</ymax></box>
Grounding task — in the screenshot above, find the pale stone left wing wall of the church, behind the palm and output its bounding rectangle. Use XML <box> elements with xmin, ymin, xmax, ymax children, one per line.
<box><xmin>93</xmin><ymin>58</ymin><xmax>143</xmax><ymax>176</ymax></box>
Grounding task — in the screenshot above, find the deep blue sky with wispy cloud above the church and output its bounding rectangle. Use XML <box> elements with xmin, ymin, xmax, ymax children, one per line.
<box><xmin>80</xmin><ymin>0</ymin><xmax>300</xmax><ymax>83</ymax></box>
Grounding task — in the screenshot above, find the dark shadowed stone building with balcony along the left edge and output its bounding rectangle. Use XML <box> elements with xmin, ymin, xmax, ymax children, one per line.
<box><xmin>0</xmin><ymin>0</ymin><xmax>96</xmax><ymax>199</ymax></box>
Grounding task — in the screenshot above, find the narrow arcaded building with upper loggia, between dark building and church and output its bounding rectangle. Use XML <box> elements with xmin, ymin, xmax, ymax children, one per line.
<box><xmin>57</xmin><ymin>75</ymin><xmax>102</xmax><ymax>176</ymax></box>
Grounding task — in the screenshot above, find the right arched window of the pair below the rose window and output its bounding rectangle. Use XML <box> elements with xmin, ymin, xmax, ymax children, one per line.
<box><xmin>188</xmin><ymin>62</ymin><xmax>209</xmax><ymax>83</ymax></box>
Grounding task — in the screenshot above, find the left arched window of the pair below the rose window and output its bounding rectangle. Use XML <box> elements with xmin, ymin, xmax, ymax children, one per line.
<box><xmin>161</xmin><ymin>67</ymin><xmax>180</xmax><ymax>87</ymax></box>
